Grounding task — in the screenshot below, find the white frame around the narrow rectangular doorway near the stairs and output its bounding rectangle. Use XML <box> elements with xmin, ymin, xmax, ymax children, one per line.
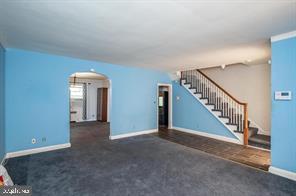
<box><xmin>156</xmin><ymin>83</ymin><xmax>173</xmax><ymax>130</ymax></box>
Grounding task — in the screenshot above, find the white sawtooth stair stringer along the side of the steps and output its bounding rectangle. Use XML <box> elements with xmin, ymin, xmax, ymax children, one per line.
<box><xmin>181</xmin><ymin>79</ymin><xmax>244</xmax><ymax>144</ymax></box>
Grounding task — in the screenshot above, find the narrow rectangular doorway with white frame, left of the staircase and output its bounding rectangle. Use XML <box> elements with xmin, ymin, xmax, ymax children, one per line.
<box><xmin>157</xmin><ymin>84</ymin><xmax>172</xmax><ymax>129</ymax></box>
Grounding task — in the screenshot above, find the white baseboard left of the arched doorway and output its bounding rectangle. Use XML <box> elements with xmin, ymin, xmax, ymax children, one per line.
<box><xmin>6</xmin><ymin>143</ymin><xmax>71</xmax><ymax>159</ymax></box>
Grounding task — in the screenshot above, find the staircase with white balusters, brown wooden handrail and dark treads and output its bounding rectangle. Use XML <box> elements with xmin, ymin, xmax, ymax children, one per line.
<box><xmin>180</xmin><ymin>70</ymin><xmax>270</xmax><ymax>148</ymax></box>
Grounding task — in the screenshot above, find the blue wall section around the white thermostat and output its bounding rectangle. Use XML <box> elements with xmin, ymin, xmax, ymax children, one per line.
<box><xmin>271</xmin><ymin>37</ymin><xmax>296</xmax><ymax>172</ymax></box>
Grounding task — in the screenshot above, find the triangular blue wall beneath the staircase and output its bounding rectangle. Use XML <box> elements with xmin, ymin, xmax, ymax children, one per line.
<box><xmin>173</xmin><ymin>82</ymin><xmax>236</xmax><ymax>139</ymax></box>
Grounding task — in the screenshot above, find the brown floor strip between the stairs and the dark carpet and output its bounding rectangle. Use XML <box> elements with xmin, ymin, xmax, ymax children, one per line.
<box><xmin>156</xmin><ymin>128</ymin><xmax>270</xmax><ymax>171</ymax></box>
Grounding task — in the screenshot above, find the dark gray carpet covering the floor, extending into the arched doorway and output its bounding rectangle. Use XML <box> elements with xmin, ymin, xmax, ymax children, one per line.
<box><xmin>6</xmin><ymin>123</ymin><xmax>296</xmax><ymax>196</ymax></box>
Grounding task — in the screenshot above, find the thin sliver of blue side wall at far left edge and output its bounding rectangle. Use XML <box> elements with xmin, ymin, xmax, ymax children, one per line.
<box><xmin>0</xmin><ymin>43</ymin><xmax>5</xmax><ymax>162</ymax></box>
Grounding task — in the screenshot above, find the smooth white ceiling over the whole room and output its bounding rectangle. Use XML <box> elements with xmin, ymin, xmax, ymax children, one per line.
<box><xmin>0</xmin><ymin>0</ymin><xmax>296</xmax><ymax>70</ymax></box>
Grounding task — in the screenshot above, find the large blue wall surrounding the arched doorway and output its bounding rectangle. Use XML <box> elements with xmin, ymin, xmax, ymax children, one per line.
<box><xmin>5</xmin><ymin>49</ymin><xmax>171</xmax><ymax>152</ymax></box>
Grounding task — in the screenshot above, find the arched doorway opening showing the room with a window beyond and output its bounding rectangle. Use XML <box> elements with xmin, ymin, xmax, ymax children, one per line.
<box><xmin>69</xmin><ymin>72</ymin><xmax>111</xmax><ymax>143</ymax></box>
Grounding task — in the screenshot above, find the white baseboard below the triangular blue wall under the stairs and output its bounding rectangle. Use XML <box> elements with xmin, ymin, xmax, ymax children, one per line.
<box><xmin>173</xmin><ymin>127</ymin><xmax>242</xmax><ymax>144</ymax></box>
